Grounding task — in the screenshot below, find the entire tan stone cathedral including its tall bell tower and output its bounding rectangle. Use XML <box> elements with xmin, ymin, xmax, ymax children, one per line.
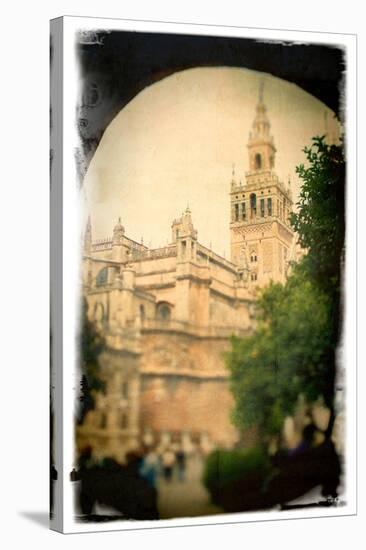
<box><xmin>77</xmin><ymin>92</ymin><xmax>296</xmax><ymax>461</ymax></box>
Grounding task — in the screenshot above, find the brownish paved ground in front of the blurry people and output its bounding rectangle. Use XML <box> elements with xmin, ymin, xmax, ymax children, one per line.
<box><xmin>158</xmin><ymin>457</ymin><xmax>223</xmax><ymax>519</ymax></box>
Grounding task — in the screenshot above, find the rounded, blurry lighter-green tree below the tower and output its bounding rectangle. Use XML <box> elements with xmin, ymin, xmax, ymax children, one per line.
<box><xmin>227</xmin><ymin>272</ymin><xmax>331</xmax><ymax>438</ymax></box>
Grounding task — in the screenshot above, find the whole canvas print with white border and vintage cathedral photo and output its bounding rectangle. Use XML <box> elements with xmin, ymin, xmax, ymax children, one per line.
<box><xmin>51</xmin><ymin>18</ymin><xmax>354</xmax><ymax>531</ymax></box>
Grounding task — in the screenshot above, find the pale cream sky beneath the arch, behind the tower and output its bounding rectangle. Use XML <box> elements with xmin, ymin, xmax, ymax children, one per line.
<box><xmin>82</xmin><ymin>67</ymin><xmax>334</xmax><ymax>258</ymax></box>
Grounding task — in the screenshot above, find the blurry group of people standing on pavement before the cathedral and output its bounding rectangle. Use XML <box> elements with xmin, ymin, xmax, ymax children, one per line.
<box><xmin>140</xmin><ymin>447</ymin><xmax>187</xmax><ymax>487</ymax></box>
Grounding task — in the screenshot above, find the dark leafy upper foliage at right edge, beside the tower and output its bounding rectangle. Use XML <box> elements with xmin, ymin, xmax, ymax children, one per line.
<box><xmin>290</xmin><ymin>137</ymin><xmax>345</xmax><ymax>298</ymax></box>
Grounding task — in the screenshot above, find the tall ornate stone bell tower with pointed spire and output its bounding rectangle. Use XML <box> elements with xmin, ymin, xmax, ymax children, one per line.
<box><xmin>230</xmin><ymin>82</ymin><xmax>294</xmax><ymax>286</ymax></box>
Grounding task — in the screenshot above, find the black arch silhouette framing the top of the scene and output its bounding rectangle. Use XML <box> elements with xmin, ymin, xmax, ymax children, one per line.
<box><xmin>77</xmin><ymin>29</ymin><xmax>344</xmax><ymax>178</ymax></box>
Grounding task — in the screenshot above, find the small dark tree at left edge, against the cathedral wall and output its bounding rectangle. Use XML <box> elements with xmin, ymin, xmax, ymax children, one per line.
<box><xmin>78</xmin><ymin>298</ymin><xmax>105</xmax><ymax>424</ymax></box>
